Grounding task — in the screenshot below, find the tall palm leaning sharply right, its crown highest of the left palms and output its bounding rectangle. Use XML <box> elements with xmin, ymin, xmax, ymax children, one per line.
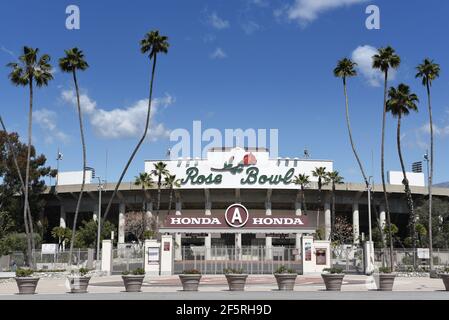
<box><xmin>103</xmin><ymin>30</ymin><xmax>169</xmax><ymax>225</ymax></box>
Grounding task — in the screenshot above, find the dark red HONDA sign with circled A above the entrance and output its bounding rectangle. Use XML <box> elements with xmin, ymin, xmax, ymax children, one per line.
<box><xmin>162</xmin><ymin>204</ymin><xmax>316</xmax><ymax>230</ymax></box>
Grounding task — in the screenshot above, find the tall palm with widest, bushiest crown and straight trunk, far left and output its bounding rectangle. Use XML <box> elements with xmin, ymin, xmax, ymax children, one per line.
<box><xmin>7</xmin><ymin>46</ymin><xmax>53</xmax><ymax>266</ymax></box>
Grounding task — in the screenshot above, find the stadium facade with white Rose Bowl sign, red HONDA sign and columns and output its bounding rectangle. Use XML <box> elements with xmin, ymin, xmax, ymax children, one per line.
<box><xmin>41</xmin><ymin>147</ymin><xmax>449</xmax><ymax>269</ymax></box>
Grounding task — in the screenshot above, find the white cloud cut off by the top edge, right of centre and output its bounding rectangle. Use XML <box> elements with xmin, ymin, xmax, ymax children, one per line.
<box><xmin>286</xmin><ymin>0</ymin><xmax>367</xmax><ymax>26</ymax></box>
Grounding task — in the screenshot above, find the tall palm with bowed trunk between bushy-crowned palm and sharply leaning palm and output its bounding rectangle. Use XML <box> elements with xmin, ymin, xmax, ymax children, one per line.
<box><xmin>59</xmin><ymin>47</ymin><xmax>89</xmax><ymax>265</ymax></box>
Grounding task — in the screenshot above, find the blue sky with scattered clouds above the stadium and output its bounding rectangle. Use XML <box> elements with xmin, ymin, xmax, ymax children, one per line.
<box><xmin>0</xmin><ymin>0</ymin><xmax>449</xmax><ymax>182</ymax></box>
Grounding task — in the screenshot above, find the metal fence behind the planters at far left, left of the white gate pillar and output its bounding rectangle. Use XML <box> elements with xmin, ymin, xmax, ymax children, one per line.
<box><xmin>0</xmin><ymin>249</ymin><xmax>94</xmax><ymax>270</ymax></box>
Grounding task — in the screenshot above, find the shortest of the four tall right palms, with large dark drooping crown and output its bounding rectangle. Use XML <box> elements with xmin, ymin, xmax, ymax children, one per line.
<box><xmin>387</xmin><ymin>83</ymin><xmax>419</xmax><ymax>266</ymax></box>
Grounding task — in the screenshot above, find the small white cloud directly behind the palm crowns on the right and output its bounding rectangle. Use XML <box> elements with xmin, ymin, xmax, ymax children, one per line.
<box><xmin>352</xmin><ymin>45</ymin><xmax>396</xmax><ymax>87</ymax></box>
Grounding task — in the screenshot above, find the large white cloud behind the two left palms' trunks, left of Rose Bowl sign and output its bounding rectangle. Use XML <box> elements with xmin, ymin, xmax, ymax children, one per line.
<box><xmin>61</xmin><ymin>90</ymin><xmax>175</xmax><ymax>141</ymax></box>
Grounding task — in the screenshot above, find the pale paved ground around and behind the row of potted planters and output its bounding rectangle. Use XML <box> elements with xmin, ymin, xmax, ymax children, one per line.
<box><xmin>0</xmin><ymin>275</ymin><xmax>449</xmax><ymax>300</ymax></box>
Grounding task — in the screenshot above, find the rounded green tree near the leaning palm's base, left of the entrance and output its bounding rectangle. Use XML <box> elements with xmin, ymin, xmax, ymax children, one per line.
<box><xmin>75</xmin><ymin>220</ymin><xmax>117</xmax><ymax>248</ymax></box>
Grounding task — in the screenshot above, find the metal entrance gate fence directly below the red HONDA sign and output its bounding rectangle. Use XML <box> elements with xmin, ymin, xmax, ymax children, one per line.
<box><xmin>174</xmin><ymin>246</ymin><xmax>302</xmax><ymax>274</ymax></box>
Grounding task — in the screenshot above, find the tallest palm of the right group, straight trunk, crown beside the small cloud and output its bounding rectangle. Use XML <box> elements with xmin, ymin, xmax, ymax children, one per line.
<box><xmin>373</xmin><ymin>46</ymin><xmax>401</xmax><ymax>271</ymax></box>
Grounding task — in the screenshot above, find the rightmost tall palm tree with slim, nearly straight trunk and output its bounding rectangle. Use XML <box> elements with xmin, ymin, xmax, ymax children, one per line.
<box><xmin>416</xmin><ymin>59</ymin><xmax>440</xmax><ymax>271</ymax></box>
